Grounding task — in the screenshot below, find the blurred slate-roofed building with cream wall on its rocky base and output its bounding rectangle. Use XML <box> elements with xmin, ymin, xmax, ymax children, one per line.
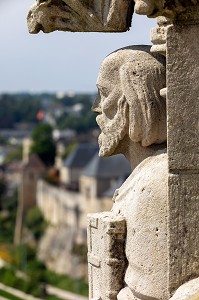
<box><xmin>37</xmin><ymin>144</ymin><xmax>130</xmax><ymax>277</ymax></box>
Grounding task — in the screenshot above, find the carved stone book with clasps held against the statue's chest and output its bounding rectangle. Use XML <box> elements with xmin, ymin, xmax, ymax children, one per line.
<box><xmin>88</xmin><ymin>212</ymin><xmax>126</xmax><ymax>300</ymax></box>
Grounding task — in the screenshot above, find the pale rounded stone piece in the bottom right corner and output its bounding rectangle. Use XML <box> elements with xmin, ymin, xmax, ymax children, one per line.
<box><xmin>170</xmin><ymin>278</ymin><xmax>199</xmax><ymax>300</ymax></box>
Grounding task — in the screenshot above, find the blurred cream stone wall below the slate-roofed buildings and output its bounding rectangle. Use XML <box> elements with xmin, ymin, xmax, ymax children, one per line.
<box><xmin>36</xmin><ymin>178</ymin><xmax>112</xmax><ymax>239</ymax></box>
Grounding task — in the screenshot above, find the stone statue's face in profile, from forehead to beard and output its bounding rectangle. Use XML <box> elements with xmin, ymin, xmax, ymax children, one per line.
<box><xmin>93</xmin><ymin>59</ymin><xmax>126</xmax><ymax>157</ymax></box>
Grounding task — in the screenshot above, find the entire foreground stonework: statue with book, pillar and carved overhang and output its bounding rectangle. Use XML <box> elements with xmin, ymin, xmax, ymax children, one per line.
<box><xmin>28</xmin><ymin>0</ymin><xmax>199</xmax><ymax>300</ymax></box>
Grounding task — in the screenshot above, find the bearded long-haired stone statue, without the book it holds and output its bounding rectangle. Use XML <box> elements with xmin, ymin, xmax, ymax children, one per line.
<box><xmin>93</xmin><ymin>46</ymin><xmax>168</xmax><ymax>300</ymax></box>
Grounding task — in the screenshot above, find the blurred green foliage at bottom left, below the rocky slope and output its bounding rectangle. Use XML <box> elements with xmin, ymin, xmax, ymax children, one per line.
<box><xmin>0</xmin><ymin>250</ymin><xmax>88</xmax><ymax>300</ymax></box>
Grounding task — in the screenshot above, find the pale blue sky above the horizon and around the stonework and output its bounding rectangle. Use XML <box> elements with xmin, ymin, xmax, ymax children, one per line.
<box><xmin>0</xmin><ymin>0</ymin><xmax>156</xmax><ymax>92</ymax></box>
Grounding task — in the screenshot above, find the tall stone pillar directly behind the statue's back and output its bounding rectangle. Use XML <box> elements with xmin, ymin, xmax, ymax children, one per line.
<box><xmin>166</xmin><ymin>6</ymin><xmax>199</xmax><ymax>293</ymax></box>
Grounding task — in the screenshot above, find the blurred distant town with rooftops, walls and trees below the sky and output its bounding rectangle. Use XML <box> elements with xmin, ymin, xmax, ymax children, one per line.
<box><xmin>0</xmin><ymin>93</ymin><xmax>130</xmax><ymax>300</ymax></box>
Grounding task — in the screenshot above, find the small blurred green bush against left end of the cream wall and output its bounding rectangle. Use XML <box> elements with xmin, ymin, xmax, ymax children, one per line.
<box><xmin>25</xmin><ymin>206</ymin><xmax>47</xmax><ymax>241</ymax></box>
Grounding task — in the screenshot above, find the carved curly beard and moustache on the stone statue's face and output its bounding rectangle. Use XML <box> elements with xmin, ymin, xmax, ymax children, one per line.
<box><xmin>96</xmin><ymin>96</ymin><xmax>128</xmax><ymax>157</ymax></box>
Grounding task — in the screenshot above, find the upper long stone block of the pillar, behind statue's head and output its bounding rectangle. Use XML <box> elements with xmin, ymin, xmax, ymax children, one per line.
<box><xmin>167</xmin><ymin>25</ymin><xmax>199</xmax><ymax>170</ymax></box>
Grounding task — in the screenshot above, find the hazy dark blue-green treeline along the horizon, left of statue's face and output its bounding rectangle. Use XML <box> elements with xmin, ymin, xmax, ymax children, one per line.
<box><xmin>0</xmin><ymin>93</ymin><xmax>96</xmax><ymax>132</ymax></box>
